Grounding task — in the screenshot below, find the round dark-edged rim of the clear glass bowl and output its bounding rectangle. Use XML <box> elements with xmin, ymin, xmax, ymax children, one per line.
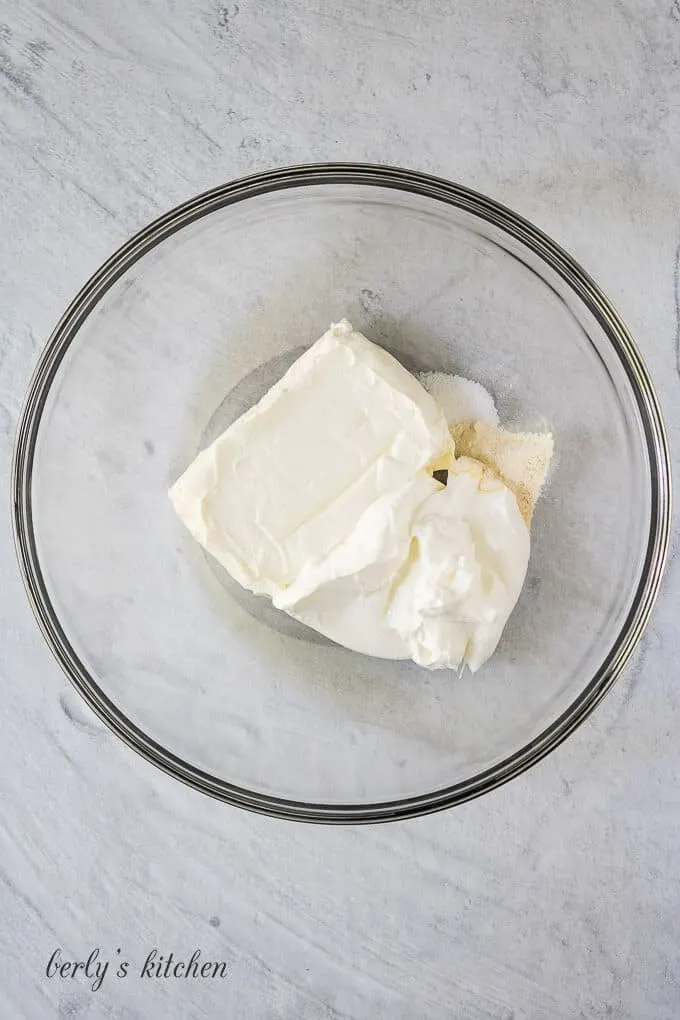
<box><xmin>11</xmin><ymin>162</ymin><xmax>671</xmax><ymax>824</ymax></box>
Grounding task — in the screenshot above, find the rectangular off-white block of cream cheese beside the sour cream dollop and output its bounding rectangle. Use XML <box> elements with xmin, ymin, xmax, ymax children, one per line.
<box><xmin>170</xmin><ymin>319</ymin><xmax>453</xmax><ymax>598</ymax></box>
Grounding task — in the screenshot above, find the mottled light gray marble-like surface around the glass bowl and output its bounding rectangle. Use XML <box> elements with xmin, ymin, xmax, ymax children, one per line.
<box><xmin>0</xmin><ymin>0</ymin><xmax>680</xmax><ymax>1020</ymax></box>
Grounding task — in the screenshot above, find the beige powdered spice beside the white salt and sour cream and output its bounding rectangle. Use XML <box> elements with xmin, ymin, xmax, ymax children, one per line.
<box><xmin>450</xmin><ymin>421</ymin><xmax>555</xmax><ymax>527</ymax></box>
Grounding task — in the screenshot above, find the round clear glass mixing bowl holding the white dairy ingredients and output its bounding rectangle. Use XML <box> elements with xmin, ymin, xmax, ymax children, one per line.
<box><xmin>13</xmin><ymin>164</ymin><xmax>670</xmax><ymax>821</ymax></box>
